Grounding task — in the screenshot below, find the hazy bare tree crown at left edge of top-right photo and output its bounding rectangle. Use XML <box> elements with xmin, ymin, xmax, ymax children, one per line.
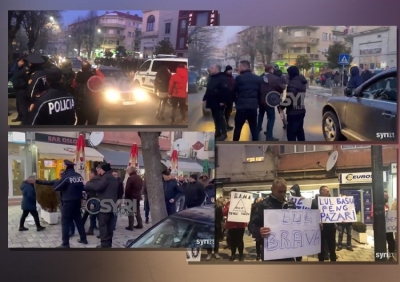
<box><xmin>188</xmin><ymin>26</ymin><xmax>223</xmax><ymax>70</ymax></box>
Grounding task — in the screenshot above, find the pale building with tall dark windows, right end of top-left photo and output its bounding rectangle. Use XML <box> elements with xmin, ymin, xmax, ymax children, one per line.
<box><xmin>140</xmin><ymin>10</ymin><xmax>179</xmax><ymax>58</ymax></box>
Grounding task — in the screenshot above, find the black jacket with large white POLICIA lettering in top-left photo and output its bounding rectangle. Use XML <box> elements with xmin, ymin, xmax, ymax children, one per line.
<box><xmin>24</xmin><ymin>83</ymin><xmax>76</xmax><ymax>125</ymax></box>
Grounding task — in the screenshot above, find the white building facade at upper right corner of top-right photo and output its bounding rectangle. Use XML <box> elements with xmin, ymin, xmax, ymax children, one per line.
<box><xmin>346</xmin><ymin>26</ymin><xmax>397</xmax><ymax>69</ymax></box>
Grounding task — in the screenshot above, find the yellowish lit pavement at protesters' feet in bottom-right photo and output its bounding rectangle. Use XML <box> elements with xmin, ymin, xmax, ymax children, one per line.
<box><xmin>201</xmin><ymin>231</ymin><xmax>397</xmax><ymax>263</ymax></box>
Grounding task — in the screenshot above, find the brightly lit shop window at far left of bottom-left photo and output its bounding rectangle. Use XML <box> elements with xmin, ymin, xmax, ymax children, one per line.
<box><xmin>8</xmin><ymin>132</ymin><xmax>32</xmax><ymax>199</ymax></box>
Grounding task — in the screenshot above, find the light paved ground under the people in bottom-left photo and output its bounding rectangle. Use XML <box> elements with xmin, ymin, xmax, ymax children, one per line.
<box><xmin>8</xmin><ymin>205</ymin><xmax>152</xmax><ymax>248</ymax></box>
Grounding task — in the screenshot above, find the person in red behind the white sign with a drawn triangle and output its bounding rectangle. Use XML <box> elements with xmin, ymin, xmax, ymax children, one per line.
<box><xmin>222</xmin><ymin>189</ymin><xmax>247</xmax><ymax>261</ymax></box>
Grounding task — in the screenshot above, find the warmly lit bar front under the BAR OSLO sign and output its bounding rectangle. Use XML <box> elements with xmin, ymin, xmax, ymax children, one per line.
<box><xmin>32</xmin><ymin>133</ymin><xmax>104</xmax><ymax>180</ymax></box>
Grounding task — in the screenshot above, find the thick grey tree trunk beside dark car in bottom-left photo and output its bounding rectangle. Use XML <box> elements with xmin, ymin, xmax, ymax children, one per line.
<box><xmin>139</xmin><ymin>132</ymin><xmax>168</xmax><ymax>223</ymax></box>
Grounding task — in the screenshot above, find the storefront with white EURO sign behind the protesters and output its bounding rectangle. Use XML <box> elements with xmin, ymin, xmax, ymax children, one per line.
<box><xmin>339</xmin><ymin>171</ymin><xmax>388</xmax><ymax>224</ymax></box>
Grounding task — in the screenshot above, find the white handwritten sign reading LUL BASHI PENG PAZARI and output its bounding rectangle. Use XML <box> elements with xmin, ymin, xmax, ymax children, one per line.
<box><xmin>318</xmin><ymin>196</ymin><xmax>357</xmax><ymax>223</ymax></box>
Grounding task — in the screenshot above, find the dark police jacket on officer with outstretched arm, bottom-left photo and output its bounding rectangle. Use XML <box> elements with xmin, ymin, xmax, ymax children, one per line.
<box><xmin>54</xmin><ymin>169</ymin><xmax>84</xmax><ymax>202</ymax></box>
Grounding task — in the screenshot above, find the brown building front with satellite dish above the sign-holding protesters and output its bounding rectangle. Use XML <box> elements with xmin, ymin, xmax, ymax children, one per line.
<box><xmin>217</xmin><ymin>145</ymin><xmax>398</xmax><ymax>224</ymax></box>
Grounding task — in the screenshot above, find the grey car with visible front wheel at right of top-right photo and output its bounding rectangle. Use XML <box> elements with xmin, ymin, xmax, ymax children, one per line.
<box><xmin>322</xmin><ymin>69</ymin><xmax>398</xmax><ymax>141</ymax></box>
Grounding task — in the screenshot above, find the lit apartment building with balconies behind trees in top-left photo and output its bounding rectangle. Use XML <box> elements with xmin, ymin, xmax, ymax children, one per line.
<box><xmin>68</xmin><ymin>11</ymin><xmax>142</xmax><ymax>57</ymax></box>
